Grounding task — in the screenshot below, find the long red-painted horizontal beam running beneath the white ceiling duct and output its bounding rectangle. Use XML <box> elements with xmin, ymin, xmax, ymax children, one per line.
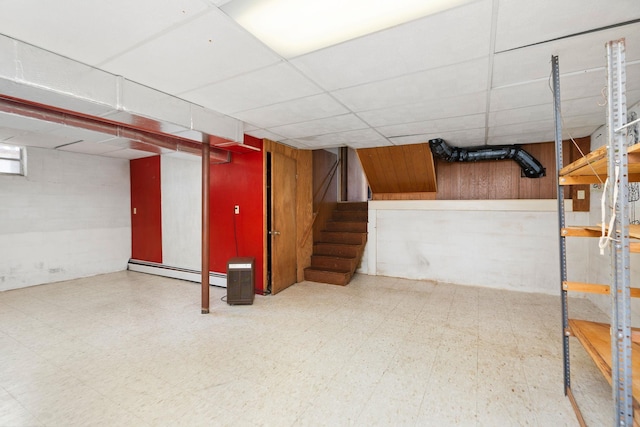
<box><xmin>0</xmin><ymin>95</ymin><xmax>231</xmax><ymax>163</ymax></box>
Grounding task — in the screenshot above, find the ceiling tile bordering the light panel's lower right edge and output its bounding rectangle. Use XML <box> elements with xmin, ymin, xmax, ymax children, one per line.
<box><xmin>291</xmin><ymin>0</ymin><xmax>492</xmax><ymax>90</ymax></box>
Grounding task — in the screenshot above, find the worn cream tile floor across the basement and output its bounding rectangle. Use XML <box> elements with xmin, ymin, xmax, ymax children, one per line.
<box><xmin>0</xmin><ymin>272</ymin><xmax>611</xmax><ymax>426</ymax></box>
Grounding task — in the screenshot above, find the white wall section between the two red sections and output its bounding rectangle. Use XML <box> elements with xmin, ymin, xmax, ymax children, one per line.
<box><xmin>160</xmin><ymin>155</ymin><xmax>202</xmax><ymax>271</ymax></box>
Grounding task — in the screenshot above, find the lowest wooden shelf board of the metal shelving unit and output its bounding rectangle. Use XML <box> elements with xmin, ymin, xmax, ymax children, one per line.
<box><xmin>569</xmin><ymin>319</ymin><xmax>640</xmax><ymax>411</ymax></box>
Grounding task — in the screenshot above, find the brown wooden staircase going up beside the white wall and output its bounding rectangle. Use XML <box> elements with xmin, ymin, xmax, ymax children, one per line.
<box><xmin>304</xmin><ymin>202</ymin><xmax>369</xmax><ymax>286</ymax></box>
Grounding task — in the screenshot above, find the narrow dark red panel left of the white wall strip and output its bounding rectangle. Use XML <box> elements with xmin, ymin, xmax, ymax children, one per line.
<box><xmin>129</xmin><ymin>156</ymin><xmax>162</xmax><ymax>263</ymax></box>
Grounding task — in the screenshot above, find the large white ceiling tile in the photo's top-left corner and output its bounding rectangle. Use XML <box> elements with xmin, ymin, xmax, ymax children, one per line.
<box><xmin>0</xmin><ymin>0</ymin><xmax>207</xmax><ymax>65</ymax></box>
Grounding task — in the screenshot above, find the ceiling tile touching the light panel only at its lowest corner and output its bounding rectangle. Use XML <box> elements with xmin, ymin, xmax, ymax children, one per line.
<box><xmin>181</xmin><ymin>62</ymin><xmax>322</xmax><ymax>114</ymax></box>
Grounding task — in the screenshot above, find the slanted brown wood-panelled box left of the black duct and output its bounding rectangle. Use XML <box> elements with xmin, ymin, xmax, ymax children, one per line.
<box><xmin>357</xmin><ymin>143</ymin><xmax>436</xmax><ymax>200</ymax></box>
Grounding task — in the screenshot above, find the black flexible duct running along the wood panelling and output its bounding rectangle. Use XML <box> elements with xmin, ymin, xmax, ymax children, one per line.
<box><xmin>429</xmin><ymin>138</ymin><xmax>546</xmax><ymax>178</ymax></box>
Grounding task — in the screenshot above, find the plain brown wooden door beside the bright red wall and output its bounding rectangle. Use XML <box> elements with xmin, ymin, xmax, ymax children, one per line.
<box><xmin>270</xmin><ymin>153</ymin><xmax>297</xmax><ymax>294</ymax></box>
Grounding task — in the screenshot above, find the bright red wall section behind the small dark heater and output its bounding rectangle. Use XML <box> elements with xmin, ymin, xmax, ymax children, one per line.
<box><xmin>209</xmin><ymin>135</ymin><xmax>264</xmax><ymax>294</ymax></box>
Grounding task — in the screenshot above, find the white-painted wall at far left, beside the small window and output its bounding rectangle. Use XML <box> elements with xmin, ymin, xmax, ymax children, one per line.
<box><xmin>0</xmin><ymin>147</ymin><xmax>131</xmax><ymax>291</ymax></box>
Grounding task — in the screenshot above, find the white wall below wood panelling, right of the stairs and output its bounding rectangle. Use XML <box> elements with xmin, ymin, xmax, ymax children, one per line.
<box><xmin>360</xmin><ymin>200</ymin><xmax>588</xmax><ymax>295</ymax></box>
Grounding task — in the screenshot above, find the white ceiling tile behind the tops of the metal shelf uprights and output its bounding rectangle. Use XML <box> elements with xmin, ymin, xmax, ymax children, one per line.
<box><xmin>493</xmin><ymin>23</ymin><xmax>640</xmax><ymax>87</ymax></box>
